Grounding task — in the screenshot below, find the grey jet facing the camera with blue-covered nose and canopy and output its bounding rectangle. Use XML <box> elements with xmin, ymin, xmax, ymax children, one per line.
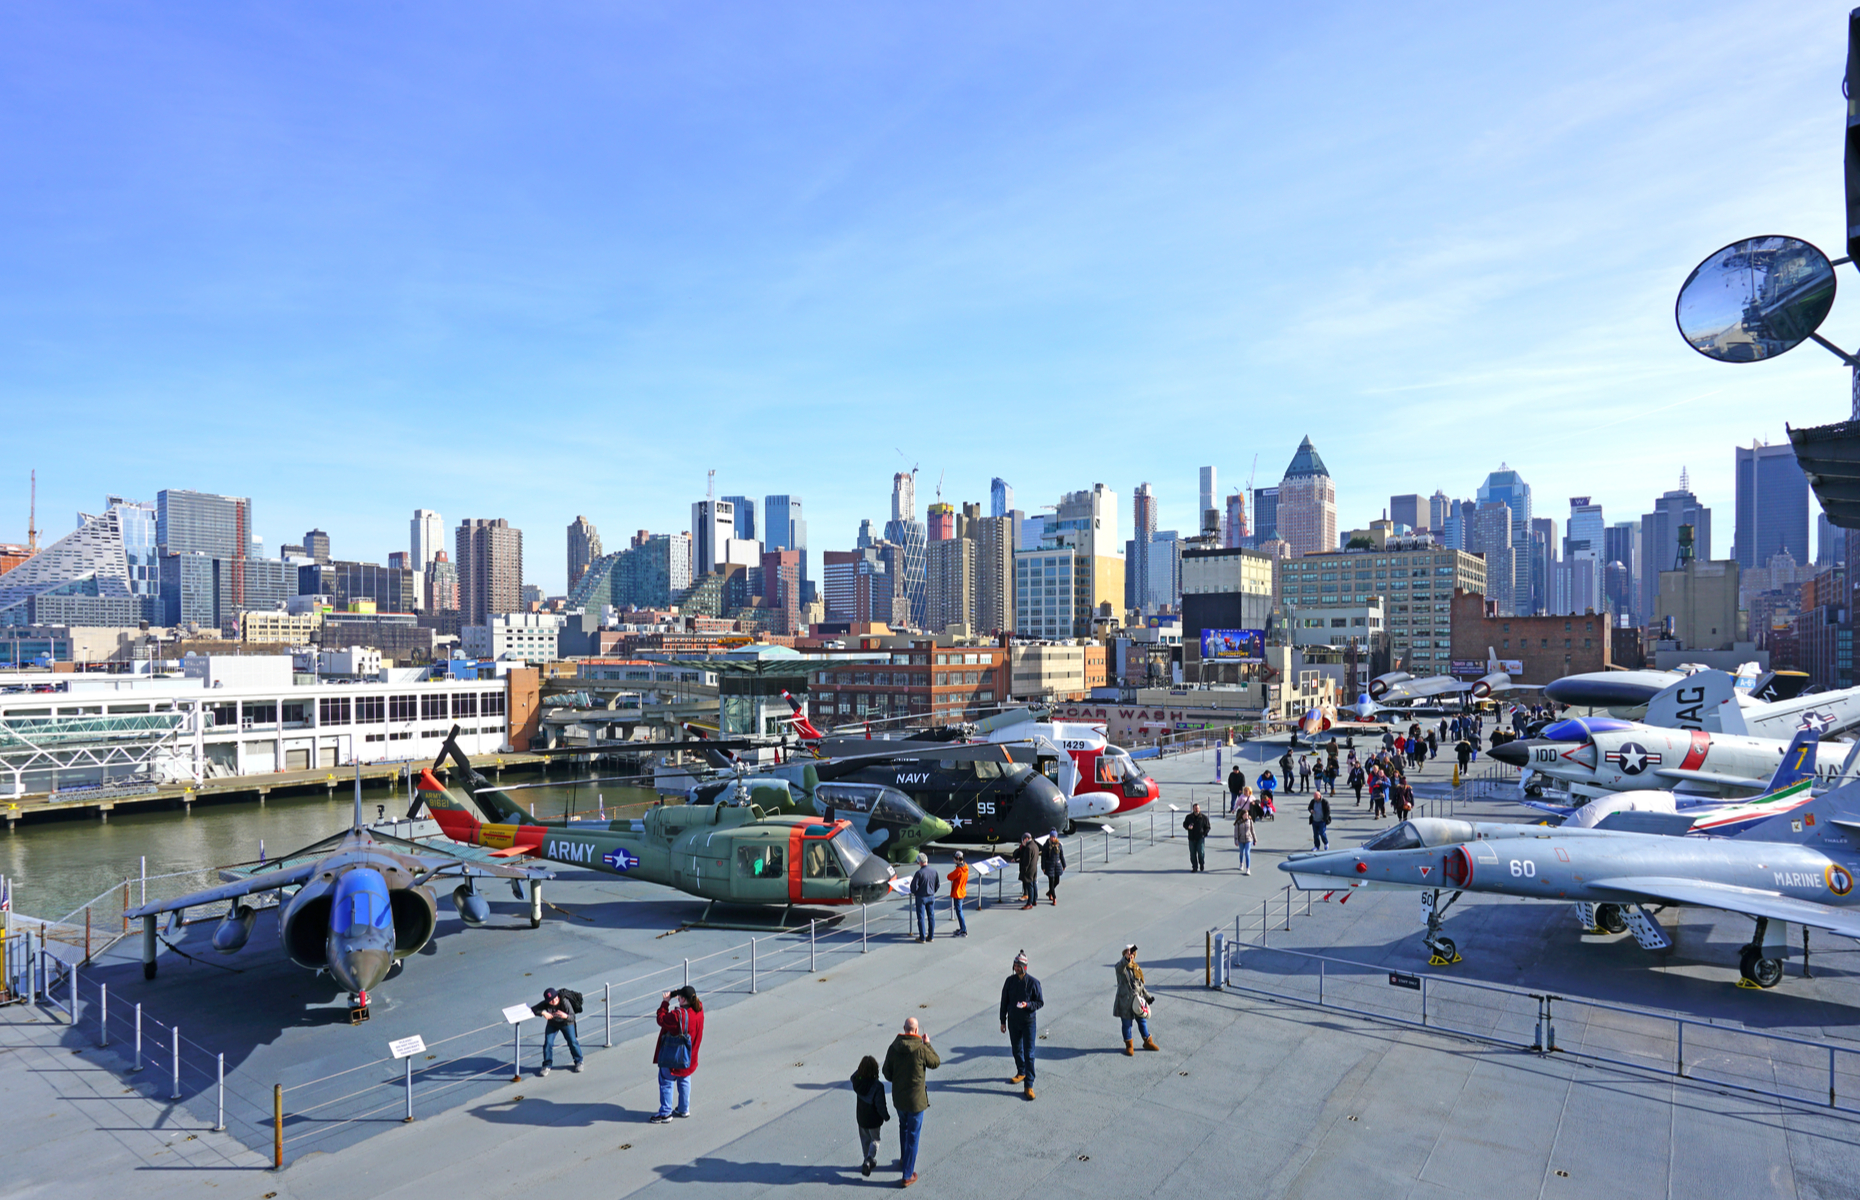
<box><xmin>125</xmin><ymin>768</ymin><xmax>552</xmax><ymax>1023</ymax></box>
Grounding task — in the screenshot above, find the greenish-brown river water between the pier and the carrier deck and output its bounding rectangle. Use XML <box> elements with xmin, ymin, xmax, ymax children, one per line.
<box><xmin>0</xmin><ymin>776</ymin><xmax>655</xmax><ymax>919</ymax></box>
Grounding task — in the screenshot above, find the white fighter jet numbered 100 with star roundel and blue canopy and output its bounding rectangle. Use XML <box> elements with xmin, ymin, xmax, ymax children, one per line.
<box><xmin>1490</xmin><ymin>716</ymin><xmax>1840</xmax><ymax>796</ymax></box>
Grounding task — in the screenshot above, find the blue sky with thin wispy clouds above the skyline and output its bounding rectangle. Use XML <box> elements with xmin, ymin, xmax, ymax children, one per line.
<box><xmin>0</xmin><ymin>2</ymin><xmax>1860</xmax><ymax>592</ymax></box>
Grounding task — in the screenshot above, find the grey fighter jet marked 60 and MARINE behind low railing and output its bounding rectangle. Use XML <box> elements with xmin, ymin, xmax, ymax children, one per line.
<box><xmin>1280</xmin><ymin>783</ymin><xmax>1860</xmax><ymax>988</ymax></box>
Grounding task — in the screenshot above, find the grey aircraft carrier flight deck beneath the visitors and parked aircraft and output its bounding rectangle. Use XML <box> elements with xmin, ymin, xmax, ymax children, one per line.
<box><xmin>0</xmin><ymin>746</ymin><xmax>1860</xmax><ymax>1200</ymax></box>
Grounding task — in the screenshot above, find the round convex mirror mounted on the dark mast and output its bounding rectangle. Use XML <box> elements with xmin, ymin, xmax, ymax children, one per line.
<box><xmin>1674</xmin><ymin>236</ymin><xmax>1834</xmax><ymax>363</ymax></box>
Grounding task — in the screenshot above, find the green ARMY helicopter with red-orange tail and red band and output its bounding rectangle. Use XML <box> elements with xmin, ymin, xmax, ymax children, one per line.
<box><xmin>409</xmin><ymin>737</ymin><xmax>893</xmax><ymax>928</ymax></box>
